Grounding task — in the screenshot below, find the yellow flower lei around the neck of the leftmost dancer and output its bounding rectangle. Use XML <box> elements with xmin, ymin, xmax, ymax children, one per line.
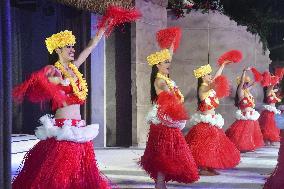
<box><xmin>54</xmin><ymin>61</ymin><xmax>88</xmax><ymax>100</ymax></box>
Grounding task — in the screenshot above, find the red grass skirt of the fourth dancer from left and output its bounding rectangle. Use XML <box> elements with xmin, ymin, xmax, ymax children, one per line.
<box><xmin>226</xmin><ymin>120</ymin><xmax>264</xmax><ymax>152</ymax></box>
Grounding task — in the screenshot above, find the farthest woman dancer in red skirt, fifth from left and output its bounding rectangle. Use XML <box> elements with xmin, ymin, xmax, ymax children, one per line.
<box><xmin>259</xmin><ymin>72</ymin><xmax>281</xmax><ymax>145</ymax></box>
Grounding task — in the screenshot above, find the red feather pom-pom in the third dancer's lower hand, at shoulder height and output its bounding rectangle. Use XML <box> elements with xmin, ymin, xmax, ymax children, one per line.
<box><xmin>213</xmin><ymin>75</ymin><xmax>230</xmax><ymax>98</ymax></box>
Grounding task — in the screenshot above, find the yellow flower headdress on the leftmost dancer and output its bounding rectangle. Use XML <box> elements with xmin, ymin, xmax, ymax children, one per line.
<box><xmin>45</xmin><ymin>30</ymin><xmax>76</xmax><ymax>54</ymax></box>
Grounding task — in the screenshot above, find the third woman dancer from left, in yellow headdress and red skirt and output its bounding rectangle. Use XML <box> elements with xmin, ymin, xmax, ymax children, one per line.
<box><xmin>185</xmin><ymin>61</ymin><xmax>240</xmax><ymax>176</ymax></box>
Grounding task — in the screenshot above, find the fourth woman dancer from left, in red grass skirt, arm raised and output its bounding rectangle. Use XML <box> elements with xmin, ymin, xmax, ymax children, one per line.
<box><xmin>226</xmin><ymin>68</ymin><xmax>263</xmax><ymax>152</ymax></box>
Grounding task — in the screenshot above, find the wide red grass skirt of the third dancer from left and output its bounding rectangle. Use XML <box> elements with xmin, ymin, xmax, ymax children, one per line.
<box><xmin>185</xmin><ymin>122</ymin><xmax>240</xmax><ymax>169</ymax></box>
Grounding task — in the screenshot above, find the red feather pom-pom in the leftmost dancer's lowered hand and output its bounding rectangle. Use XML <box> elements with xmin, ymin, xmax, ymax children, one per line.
<box><xmin>12</xmin><ymin>66</ymin><xmax>66</xmax><ymax>110</ymax></box>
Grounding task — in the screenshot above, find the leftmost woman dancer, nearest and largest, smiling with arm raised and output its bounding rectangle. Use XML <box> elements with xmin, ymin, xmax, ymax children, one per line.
<box><xmin>12</xmin><ymin>29</ymin><xmax>111</xmax><ymax>189</ymax></box>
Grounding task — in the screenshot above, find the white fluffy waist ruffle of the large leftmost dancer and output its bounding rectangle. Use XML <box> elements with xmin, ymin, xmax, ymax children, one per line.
<box><xmin>35</xmin><ymin>114</ymin><xmax>99</xmax><ymax>143</ymax></box>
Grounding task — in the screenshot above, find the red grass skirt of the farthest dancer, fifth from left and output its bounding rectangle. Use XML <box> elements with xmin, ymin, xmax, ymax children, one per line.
<box><xmin>258</xmin><ymin>110</ymin><xmax>280</xmax><ymax>142</ymax></box>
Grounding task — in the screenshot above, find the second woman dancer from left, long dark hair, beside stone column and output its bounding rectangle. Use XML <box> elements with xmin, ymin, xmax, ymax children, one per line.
<box><xmin>140</xmin><ymin>49</ymin><xmax>199</xmax><ymax>189</ymax></box>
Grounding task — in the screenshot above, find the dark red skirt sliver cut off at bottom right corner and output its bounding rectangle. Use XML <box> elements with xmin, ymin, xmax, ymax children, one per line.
<box><xmin>264</xmin><ymin>130</ymin><xmax>284</xmax><ymax>189</ymax></box>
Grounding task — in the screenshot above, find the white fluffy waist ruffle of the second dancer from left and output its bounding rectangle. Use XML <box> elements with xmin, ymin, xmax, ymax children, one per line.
<box><xmin>146</xmin><ymin>104</ymin><xmax>186</xmax><ymax>130</ymax></box>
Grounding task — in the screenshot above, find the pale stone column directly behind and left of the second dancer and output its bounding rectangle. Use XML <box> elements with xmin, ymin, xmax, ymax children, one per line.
<box><xmin>131</xmin><ymin>0</ymin><xmax>168</xmax><ymax>146</ymax></box>
